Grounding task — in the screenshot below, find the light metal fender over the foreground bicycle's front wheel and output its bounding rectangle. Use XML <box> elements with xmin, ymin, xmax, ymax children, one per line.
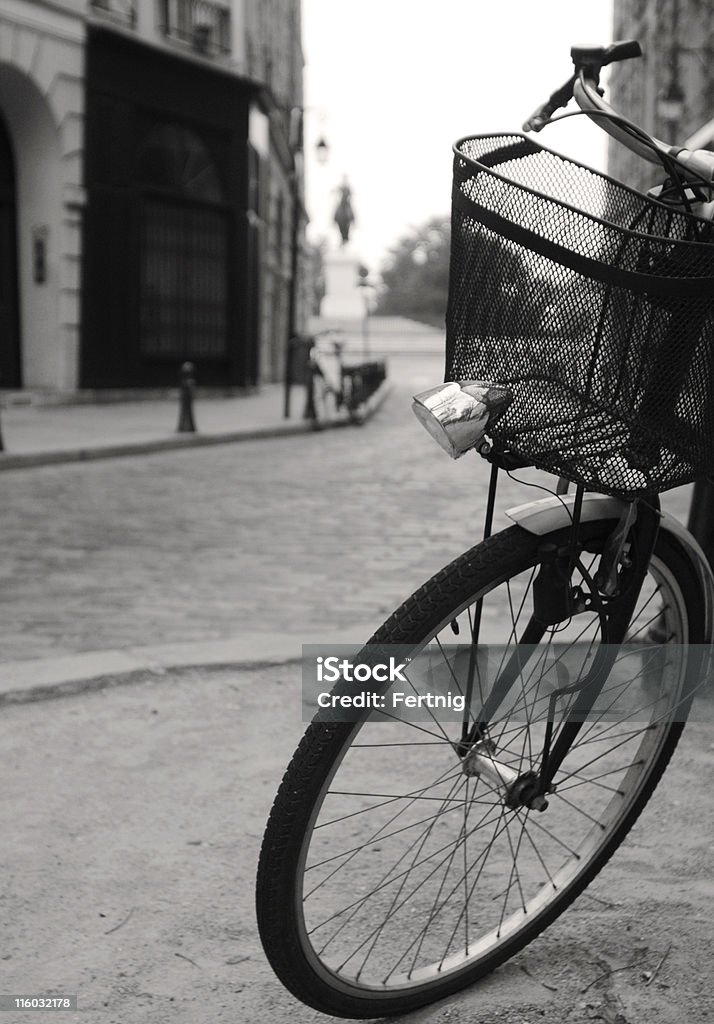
<box><xmin>506</xmin><ymin>494</ymin><xmax>714</xmax><ymax>643</ymax></box>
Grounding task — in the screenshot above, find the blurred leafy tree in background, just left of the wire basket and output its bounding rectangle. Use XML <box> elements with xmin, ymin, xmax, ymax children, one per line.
<box><xmin>376</xmin><ymin>217</ymin><xmax>451</xmax><ymax>327</ymax></box>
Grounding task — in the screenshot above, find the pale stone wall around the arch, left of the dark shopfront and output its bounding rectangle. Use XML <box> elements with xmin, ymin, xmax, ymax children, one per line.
<box><xmin>0</xmin><ymin>0</ymin><xmax>85</xmax><ymax>388</ymax></box>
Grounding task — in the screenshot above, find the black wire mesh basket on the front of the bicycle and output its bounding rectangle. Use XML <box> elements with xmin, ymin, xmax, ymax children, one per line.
<box><xmin>446</xmin><ymin>135</ymin><xmax>714</xmax><ymax>498</ymax></box>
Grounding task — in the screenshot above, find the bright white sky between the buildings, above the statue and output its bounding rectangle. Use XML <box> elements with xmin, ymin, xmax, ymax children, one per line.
<box><xmin>302</xmin><ymin>0</ymin><xmax>613</xmax><ymax>271</ymax></box>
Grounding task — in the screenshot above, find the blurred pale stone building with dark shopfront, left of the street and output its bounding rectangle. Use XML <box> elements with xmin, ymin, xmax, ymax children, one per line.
<box><xmin>0</xmin><ymin>0</ymin><xmax>305</xmax><ymax>391</ymax></box>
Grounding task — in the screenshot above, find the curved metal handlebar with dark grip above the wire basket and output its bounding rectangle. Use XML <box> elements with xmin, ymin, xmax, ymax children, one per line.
<box><xmin>523</xmin><ymin>39</ymin><xmax>714</xmax><ymax>185</ymax></box>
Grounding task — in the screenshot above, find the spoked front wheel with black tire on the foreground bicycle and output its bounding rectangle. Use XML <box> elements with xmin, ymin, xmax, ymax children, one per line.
<box><xmin>257</xmin><ymin>521</ymin><xmax>704</xmax><ymax>1018</ymax></box>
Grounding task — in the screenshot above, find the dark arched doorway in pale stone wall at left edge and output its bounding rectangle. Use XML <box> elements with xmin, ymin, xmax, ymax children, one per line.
<box><xmin>0</xmin><ymin>117</ymin><xmax>22</xmax><ymax>388</ymax></box>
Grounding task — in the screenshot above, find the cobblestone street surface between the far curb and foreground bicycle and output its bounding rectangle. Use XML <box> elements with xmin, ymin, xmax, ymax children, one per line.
<box><xmin>0</xmin><ymin>319</ymin><xmax>687</xmax><ymax>694</ymax></box>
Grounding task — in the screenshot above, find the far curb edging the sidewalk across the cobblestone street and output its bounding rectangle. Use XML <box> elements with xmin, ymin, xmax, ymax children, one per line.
<box><xmin>0</xmin><ymin>381</ymin><xmax>391</xmax><ymax>471</ymax></box>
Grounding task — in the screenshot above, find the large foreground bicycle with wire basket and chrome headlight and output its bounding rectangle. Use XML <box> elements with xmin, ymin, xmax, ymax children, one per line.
<box><xmin>257</xmin><ymin>42</ymin><xmax>714</xmax><ymax>1018</ymax></box>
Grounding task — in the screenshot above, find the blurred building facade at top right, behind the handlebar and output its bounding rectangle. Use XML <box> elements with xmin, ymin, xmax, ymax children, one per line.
<box><xmin>608</xmin><ymin>0</ymin><xmax>714</xmax><ymax>188</ymax></box>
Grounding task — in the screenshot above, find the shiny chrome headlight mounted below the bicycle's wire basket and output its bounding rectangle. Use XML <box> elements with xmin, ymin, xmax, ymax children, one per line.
<box><xmin>412</xmin><ymin>381</ymin><xmax>513</xmax><ymax>459</ymax></box>
